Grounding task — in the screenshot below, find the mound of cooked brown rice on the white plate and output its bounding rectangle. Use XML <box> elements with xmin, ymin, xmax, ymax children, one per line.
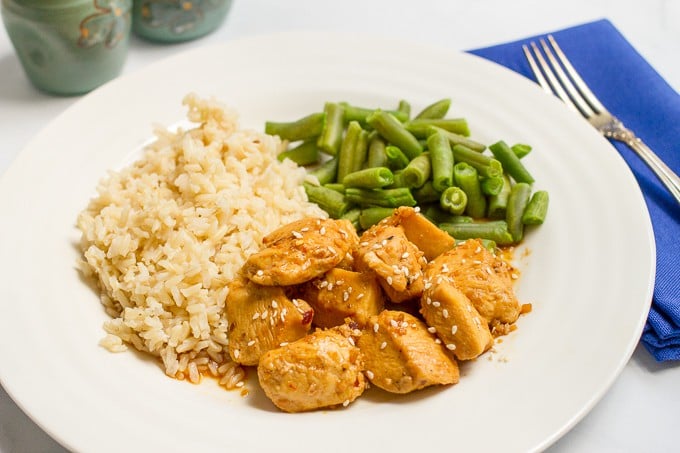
<box><xmin>78</xmin><ymin>94</ymin><xmax>325</xmax><ymax>388</ymax></box>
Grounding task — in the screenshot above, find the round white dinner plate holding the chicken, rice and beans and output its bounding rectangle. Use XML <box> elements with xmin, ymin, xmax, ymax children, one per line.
<box><xmin>0</xmin><ymin>33</ymin><xmax>655</xmax><ymax>452</ymax></box>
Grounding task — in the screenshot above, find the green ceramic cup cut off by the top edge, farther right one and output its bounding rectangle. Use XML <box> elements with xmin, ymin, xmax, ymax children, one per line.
<box><xmin>132</xmin><ymin>0</ymin><xmax>232</xmax><ymax>43</ymax></box>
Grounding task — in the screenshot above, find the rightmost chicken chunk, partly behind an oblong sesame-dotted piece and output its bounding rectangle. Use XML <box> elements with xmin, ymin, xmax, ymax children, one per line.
<box><xmin>425</xmin><ymin>239</ymin><xmax>521</xmax><ymax>324</ymax></box>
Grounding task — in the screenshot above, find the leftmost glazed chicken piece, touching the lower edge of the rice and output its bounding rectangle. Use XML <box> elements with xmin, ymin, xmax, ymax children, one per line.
<box><xmin>226</xmin><ymin>276</ymin><xmax>314</xmax><ymax>365</ymax></box>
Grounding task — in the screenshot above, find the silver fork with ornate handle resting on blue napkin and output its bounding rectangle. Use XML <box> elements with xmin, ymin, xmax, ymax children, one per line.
<box><xmin>522</xmin><ymin>35</ymin><xmax>680</xmax><ymax>203</ymax></box>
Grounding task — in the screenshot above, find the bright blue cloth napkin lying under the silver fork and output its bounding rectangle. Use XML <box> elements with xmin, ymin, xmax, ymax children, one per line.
<box><xmin>470</xmin><ymin>20</ymin><xmax>680</xmax><ymax>361</ymax></box>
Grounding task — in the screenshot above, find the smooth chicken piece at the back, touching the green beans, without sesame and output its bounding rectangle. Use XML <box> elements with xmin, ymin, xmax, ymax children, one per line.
<box><xmin>383</xmin><ymin>206</ymin><xmax>456</xmax><ymax>261</ymax></box>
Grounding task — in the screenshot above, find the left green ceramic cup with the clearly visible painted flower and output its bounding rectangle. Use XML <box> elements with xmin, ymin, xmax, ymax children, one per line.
<box><xmin>2</xmin><ymin>0</ymin><xmax>132</xmax><ymax>95</ymax></box>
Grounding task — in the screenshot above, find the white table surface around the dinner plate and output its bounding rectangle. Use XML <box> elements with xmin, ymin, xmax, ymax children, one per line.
<box><xmin>0</xmin><ymin>0</ymin><xmax>680</xmax><ymax>453</ymax></box>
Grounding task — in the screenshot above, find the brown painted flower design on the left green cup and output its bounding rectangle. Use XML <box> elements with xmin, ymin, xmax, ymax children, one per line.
<box><xmin>78</xmin><ymin>0</ymin><xmax>131</xmax><ymax>48</ymax></box>
